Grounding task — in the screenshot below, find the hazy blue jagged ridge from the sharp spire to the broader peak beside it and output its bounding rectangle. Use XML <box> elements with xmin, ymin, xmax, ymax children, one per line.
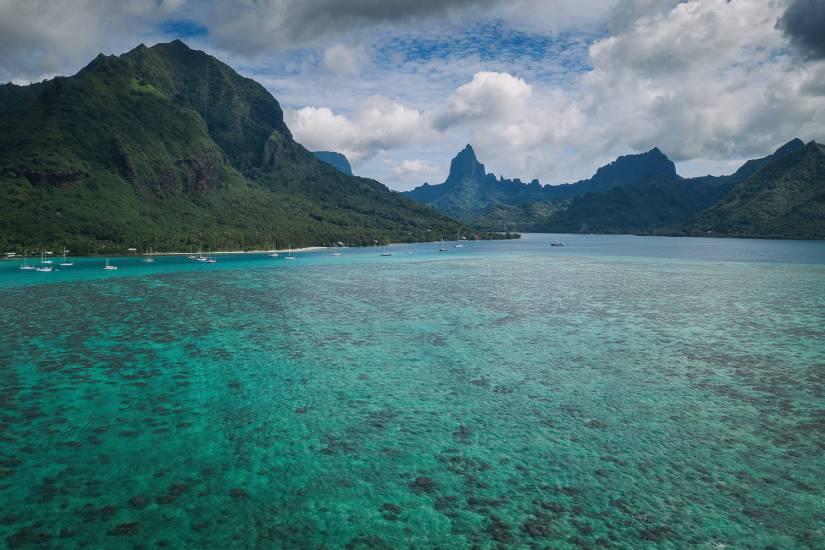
<box><xmin>406</xmin><ymin>145</ymin><xmax>678</xmax><ymax>226</ymax></box>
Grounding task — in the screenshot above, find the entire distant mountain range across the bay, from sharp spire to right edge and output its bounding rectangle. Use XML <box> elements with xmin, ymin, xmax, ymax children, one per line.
<box><xmin>406</xmin><ymin>139</ymin><xmax>825</xmax><ymax>238</ymax></box>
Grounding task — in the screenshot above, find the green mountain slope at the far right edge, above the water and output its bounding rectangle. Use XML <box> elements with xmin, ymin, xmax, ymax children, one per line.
<box><xmin>687</xmin><ymin>141</ymin><xmax>825</xmax><ymax>239</ymax></box>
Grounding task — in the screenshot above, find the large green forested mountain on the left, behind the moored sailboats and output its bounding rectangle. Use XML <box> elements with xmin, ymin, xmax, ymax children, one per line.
<box><xmin>0</xmin><ymin>40</ymin><xmax>462</xmax><ymax>253</ymax></box>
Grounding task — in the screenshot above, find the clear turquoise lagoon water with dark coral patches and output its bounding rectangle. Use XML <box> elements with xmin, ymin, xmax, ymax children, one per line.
<box><xmin>0</xmin><ymin>235</ymin><xmax>825</xmax><ymax>549</ymax></box>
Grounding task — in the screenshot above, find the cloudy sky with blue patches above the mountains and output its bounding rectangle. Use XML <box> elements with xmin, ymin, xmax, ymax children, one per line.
<box><xmin>0</xmin><ymin>0</ymin><xmax>825</xmax><ymax>189</ymax></box>
